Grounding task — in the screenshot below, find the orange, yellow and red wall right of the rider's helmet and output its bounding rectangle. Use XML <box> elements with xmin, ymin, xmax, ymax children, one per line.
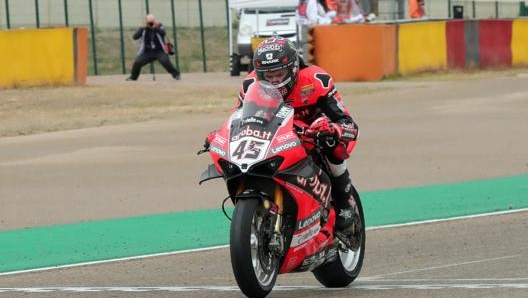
<box><xmin>308</xmin><ymin>19</ymin><xmax>528</xmax><ymax>81</ymax></box>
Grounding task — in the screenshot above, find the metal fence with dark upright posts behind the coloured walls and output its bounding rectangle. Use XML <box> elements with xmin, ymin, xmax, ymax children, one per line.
<box><xmin>0</xmin><ymin>0</ymin><xmax>527</xmax><ymax>75</ymax></box>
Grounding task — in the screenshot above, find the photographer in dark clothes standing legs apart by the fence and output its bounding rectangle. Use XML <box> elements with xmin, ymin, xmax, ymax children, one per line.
<box><xmin>127</xmin><ymin>14</ymin><xmax>180</xmax><ymax>81</ymax></box>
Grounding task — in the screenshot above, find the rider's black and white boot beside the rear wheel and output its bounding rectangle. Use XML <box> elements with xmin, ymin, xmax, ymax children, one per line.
<box><xmin>330</xmin><ymin>170</ymin><xmax>360</xmax><ymax>236</ymax></box>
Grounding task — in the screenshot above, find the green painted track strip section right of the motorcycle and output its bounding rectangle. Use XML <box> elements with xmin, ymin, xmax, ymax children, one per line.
<box><xmin>359</xmin><ymin>175</ymin><xmax>528</xmax><ymax>226</ymax></box>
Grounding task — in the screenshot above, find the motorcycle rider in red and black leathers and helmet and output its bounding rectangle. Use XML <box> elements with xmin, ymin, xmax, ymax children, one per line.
<box><xmin>205</xmin><ymin>36</ymin><xmax>359</xmax><ymax>236</ymax></box>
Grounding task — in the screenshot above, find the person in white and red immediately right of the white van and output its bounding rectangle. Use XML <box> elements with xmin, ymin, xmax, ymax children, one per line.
<box><xmin>297</xmin><ymin>0</ymin><xmax>336</xmax><ymax>26</ymax></box>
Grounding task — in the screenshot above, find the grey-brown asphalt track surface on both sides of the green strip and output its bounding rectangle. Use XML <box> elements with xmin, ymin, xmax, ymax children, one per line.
<box><xmin>0</xmin><ymin>74</ymin><xmax>528</xmax><ymax>298</ymax></box>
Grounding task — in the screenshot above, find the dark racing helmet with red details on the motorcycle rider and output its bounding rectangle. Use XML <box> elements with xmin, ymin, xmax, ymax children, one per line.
<box><xmin>253</xmin><ymin>36</ymin><xmax>299</xmax><ymax>98</ymax></box>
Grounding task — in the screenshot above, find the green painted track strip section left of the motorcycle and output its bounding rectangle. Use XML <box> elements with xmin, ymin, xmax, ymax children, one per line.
<box><xmin>0</xmin><ymin>210</ymin><xmax>230</xmax><ymax>272</ymax></box>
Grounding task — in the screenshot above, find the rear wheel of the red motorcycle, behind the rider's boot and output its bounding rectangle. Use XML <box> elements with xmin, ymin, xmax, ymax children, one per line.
<box><xmin>312</xmin><ymin>186</ymin><xmax>365</xmax><ymax>288</ymax></box>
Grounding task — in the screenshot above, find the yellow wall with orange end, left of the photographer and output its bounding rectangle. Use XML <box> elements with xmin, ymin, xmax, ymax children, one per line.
<box><xmin>0</xmin><ymin>27</ymin><xmax>88</xmax><ymax>88</ymax></box>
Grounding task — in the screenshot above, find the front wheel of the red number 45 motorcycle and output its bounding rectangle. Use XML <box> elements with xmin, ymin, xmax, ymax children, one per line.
<box><xmin>230</xmin><ymin>198</ymin><xmax>279</xmax><ymax>298</ymax></box>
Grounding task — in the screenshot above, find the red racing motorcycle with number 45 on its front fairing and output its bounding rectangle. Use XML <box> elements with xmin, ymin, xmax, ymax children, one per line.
<box><xmin>198</xmin><ymin>82</ymin><xmax>365</xmax><ymax>298</ymax></box>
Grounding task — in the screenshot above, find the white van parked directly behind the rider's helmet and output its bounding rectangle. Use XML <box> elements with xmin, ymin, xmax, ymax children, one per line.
<box><xmin>231</xmin><ymin>6</ymin><xmax>297</xmax><ymax>76</ymax></box>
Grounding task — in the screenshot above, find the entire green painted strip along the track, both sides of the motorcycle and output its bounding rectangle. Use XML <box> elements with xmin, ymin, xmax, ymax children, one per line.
<box><xmin>0</xmin><ymin>175</ymin><xmax>528</xmax><ymax>273</ymax></box>
